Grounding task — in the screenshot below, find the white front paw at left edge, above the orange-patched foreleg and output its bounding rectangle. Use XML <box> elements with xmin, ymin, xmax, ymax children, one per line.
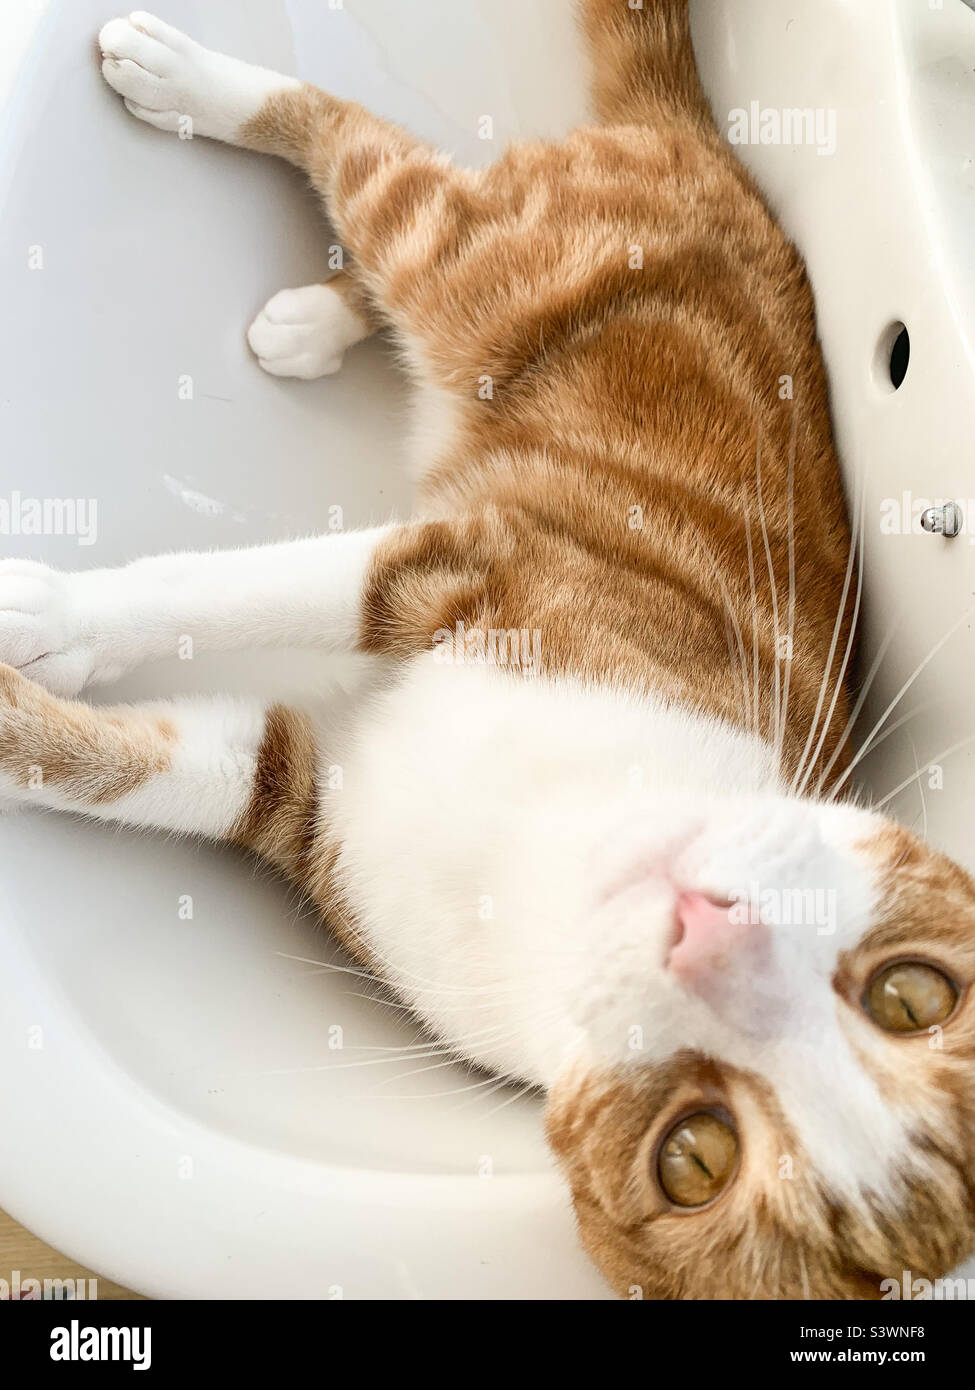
<box><xmin>0</xmin><ymin>560</ymin><xmax>95</xmax><ymax>695</ymax></box>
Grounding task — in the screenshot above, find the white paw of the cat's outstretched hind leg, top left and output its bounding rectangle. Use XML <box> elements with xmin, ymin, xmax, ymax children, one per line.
<box><xmin>99</xmin><ymin>10</ymin><xmax>300</xmax><ymax>143</ymax></box>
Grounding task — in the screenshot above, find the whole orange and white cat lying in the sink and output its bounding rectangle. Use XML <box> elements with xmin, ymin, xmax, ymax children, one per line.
<box><xmin>0</xmin><ymin>0</ymin><xmax>975</xmax><ymax>1297</ymax></box>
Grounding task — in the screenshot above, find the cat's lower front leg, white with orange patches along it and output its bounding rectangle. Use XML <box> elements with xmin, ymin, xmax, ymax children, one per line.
<box><xmin>0</xmin><ymin>664</ymin><xmax>335</xmax><ymax>873</ymax></box>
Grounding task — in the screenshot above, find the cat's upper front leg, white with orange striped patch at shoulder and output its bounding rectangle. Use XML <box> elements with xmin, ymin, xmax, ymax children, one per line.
<box><xmin>0</xmin><ymin>514</ymin><xmax>486</xmax><ymax>695</ymax></box>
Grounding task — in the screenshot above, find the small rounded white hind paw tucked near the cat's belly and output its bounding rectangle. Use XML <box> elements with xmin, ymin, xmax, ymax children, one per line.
<box><xmin>248</xmin><ymin>285</ymin><xmax>370</xmax><ymax>381</ymax></box>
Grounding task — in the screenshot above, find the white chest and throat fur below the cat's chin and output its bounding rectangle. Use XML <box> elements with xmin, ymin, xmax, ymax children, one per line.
<box><xmin>325</xmin><ymin>653</ymin><xmax>775</xmax><ymax>1083</ymax></box>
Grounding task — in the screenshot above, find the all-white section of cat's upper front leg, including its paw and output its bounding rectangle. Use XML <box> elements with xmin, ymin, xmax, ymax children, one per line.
<box><xmin>0</xmin><ymin>527</ymin><xmax>398</xmax><ymax>695</ymax></box>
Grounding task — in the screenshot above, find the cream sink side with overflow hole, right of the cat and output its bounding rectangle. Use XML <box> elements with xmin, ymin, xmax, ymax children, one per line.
<box><xmin>694</xmin><ymin>0</ymin><xmax>975</xmax><ymax>869</ymax></box>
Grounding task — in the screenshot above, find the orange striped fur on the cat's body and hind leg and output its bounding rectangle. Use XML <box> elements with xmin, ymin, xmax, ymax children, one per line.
<box><xmin>243</xmin><ymin>3</ymin><xmax>854</xmax><ymax>770</ymax></box>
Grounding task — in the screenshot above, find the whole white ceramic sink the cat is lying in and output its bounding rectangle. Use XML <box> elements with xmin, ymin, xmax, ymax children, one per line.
<box><xmin>0</xmin><ymin>0</ymin><xmax>975</xmax><ymax>1298</ymax></box>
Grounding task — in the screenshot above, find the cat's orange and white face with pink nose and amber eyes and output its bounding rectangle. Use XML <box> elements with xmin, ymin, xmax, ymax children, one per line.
<box><xmin>548</xmin><ymin>801</ymin><xmax>975</xmax><ymax>1298</ymax></box>
